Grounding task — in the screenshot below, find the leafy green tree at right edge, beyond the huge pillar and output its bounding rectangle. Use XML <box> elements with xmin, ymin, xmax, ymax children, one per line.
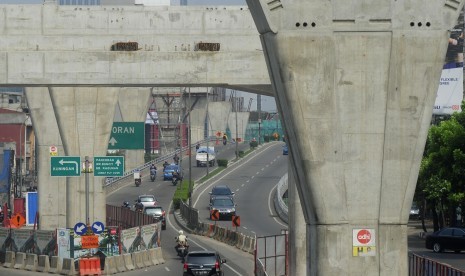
<box><xmin>416</xmin><ymin>102</ymin><xmax>465</xmax><ymax>231</ymax></box>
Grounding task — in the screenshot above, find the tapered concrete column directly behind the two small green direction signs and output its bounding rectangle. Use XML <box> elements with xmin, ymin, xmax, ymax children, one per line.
<box><xmin>50</xmin><ymin>87</ymin><xmax>118</xmax><ymax>227</ymax></box>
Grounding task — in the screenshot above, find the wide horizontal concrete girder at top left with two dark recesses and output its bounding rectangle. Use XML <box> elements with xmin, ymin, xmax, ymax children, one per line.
<box><xmin>0</xmin><ymin>4</ymin><xmax>272</xmax><ymax>95</ymax></box>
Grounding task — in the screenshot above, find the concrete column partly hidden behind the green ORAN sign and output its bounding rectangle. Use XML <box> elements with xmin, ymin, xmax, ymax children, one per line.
<box><xmin>118</xmin><ymin>87</ymin><xmax>151</xmax><ymax>170</ymax></box>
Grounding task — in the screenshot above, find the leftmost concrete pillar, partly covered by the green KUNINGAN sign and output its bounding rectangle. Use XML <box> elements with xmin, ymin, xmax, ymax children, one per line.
<box><xmin>26</xmin><ymin>87</ymin><xmax>67</xmax><ymax>230</ymax></box>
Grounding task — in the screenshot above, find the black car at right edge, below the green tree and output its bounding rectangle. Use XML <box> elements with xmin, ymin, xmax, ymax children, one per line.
<box><xmin>425</xmin><ymin>227</ymin><xmax>465</xmax><ymax>253</ymax></box>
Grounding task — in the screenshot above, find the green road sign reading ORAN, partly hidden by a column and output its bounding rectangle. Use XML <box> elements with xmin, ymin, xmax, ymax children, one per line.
<box><xmin>108</xmin><ymin>122</ymin><xmax>145</xmax><ymax>149</ymax></box>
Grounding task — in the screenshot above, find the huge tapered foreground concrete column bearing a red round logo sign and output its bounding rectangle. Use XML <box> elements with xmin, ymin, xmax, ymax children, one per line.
<box><xmin>247</xmin><ymin>0</ymin><xmax>464</xmax><ymax>276</ymax></box>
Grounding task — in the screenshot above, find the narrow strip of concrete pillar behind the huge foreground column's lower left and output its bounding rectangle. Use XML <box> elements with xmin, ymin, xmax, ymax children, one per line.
<box><xmin>287</xmin><ymin>167</ymin><xmax>309</xmax><ymax>275</ymax></box>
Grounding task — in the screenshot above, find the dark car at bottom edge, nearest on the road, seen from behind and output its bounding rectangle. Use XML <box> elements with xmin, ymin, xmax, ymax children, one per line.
<box><xmin>183</xmin><ymin>250</ymin><xmax>226</xmax><ymax>276</ymax></box>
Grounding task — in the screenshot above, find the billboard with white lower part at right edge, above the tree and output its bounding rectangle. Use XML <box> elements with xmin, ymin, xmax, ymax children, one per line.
<box><xmin>433</xmin><ymin>13</ymin><xmax>463</xmax><ymax>115</ymax></box>
